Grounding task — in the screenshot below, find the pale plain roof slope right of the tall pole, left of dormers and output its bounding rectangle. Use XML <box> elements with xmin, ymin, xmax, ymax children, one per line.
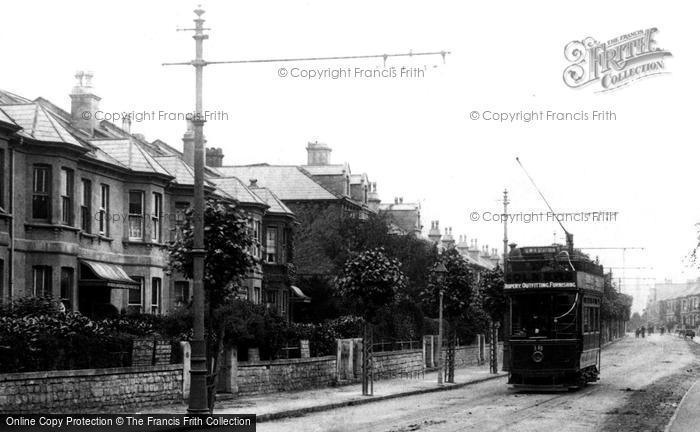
<box><xmin>216</xmin><ymin>165</ymin><xmax>341</xmax><ymax>201</ymax></box>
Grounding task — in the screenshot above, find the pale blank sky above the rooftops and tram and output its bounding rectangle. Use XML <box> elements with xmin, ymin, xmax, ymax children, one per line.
<box><xmin>0</xmin><ymin>0</ymin><xmax>700</xmax><ymax>310</ymax></box>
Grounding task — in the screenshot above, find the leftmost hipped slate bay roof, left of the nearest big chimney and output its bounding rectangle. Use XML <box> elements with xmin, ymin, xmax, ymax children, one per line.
<box><xmin>2</xmin><ymin>102</ymin><xmax>87</xmax><ymax>148</ymax></box>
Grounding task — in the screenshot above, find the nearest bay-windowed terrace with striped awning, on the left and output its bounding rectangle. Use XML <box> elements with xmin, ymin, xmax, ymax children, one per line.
<box><xmin>0</xmin><ymin>73</ymin><xmax>298</xmax><ymax>316</ymax></box>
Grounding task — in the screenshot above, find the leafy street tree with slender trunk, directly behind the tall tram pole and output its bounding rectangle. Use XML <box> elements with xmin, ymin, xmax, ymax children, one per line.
<box><xmin>168</xmin><ymin>198</ymin><xmax>256</xmax><ymax>410</ymax></box>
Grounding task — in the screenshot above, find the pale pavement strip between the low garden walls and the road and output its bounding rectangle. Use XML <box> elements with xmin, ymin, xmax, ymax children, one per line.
<box><xmin>148</xmin><ymin>365</ymin><xmax>507</xmax><ymax>423</ymax></box>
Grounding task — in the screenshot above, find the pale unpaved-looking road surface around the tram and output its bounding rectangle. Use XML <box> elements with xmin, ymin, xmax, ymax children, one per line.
<box><xmin>257</xmin><ymin>335</ymin><xmax>700</xmax><ymax>432</ymax></box>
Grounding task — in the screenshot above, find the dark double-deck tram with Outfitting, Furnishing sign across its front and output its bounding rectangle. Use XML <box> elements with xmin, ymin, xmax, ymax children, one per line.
<box><xmin>504</xmin><ymin>235</ymin><xmax>605</xmax><ymax>390</ymax></box>
